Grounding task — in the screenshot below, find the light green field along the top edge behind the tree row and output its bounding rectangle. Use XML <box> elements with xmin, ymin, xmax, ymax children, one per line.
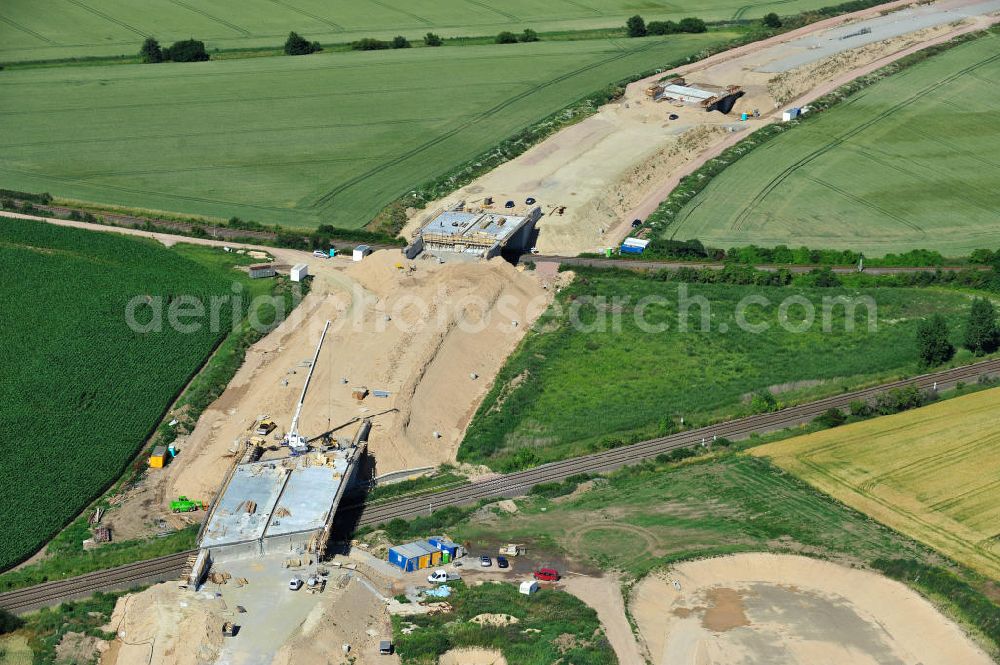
<box><xmin>0</xmin><ymin>0</ymin><xmax>835</xmax><ymax>62</ymax></box>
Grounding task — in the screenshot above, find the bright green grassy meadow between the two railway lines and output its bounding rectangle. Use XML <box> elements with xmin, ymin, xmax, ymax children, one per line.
<box><xmin>459</xmin><ymin>271</ymin><xmax>970</xmax><ymax>469</ymax></box>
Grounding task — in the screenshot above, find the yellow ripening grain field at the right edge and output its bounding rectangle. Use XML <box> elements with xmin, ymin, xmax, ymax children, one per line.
<box><xmin>751</xmin><ymin>389</ymin><xmax>1000</xmax><ymax>579</ymax></box>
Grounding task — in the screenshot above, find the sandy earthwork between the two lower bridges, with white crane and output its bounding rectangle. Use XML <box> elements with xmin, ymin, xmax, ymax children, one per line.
<box><xmin>109</xmin><ymin>246</ymin><xmax>558</xmax><ymax>538</ymax></box>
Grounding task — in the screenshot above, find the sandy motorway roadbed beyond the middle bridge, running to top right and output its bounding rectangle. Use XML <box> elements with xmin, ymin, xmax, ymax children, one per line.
<box><xmin>404</xmin><ymin>0</ymin><xmax>1000</xmax><ymax>255</ymax></box>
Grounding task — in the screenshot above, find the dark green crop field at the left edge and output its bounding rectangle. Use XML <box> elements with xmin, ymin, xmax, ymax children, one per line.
<box><xmin>0</xmin><ymin>219</ymin><xmax>258</xmax><ymax>569</ymax></box>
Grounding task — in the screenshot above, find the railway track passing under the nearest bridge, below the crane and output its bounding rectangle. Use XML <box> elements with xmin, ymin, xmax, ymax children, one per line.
<box><xmin>0</xmin><ymin>359</ymin><xmax>1000</xmax><ymax>612</ymax></box>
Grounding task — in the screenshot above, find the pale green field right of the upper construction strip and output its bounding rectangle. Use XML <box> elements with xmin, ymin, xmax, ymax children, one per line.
<box><xmin>664</xmin><ymin>32</ymin><xmax>1000</xmax><ymax>256</ymax></box>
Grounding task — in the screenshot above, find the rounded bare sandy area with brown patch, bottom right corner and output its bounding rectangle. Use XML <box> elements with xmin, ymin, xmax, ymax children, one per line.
<box><xmin>630</xmin><ymin>554</ymin><xmax>992</xmax><ymax>665</ymax></box>
